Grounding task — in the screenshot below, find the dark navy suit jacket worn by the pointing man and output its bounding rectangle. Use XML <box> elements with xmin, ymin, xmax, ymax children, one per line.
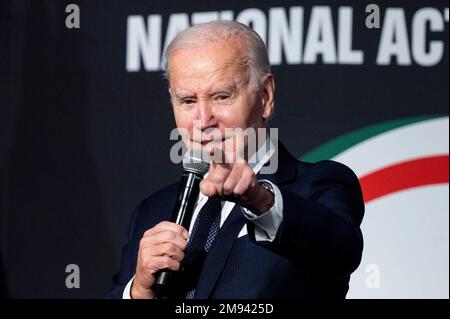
<box><xmin>106</xmin><ymin>143</ymin><xmax>364</xmax><ymax>299</ymax></box>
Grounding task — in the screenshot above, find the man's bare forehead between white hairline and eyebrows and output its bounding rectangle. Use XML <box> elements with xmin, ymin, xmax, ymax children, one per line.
<box><xmin>169</xmin><ymin>40</ymin><xmax>247</xmax><ymax>90</ymax></box>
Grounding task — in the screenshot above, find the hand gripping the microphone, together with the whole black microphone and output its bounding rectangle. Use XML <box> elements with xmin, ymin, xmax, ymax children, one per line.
<box><xmin>131</xmin><ymin>150</ymin><xmax>210</xmax><ymax>299</ymax></box>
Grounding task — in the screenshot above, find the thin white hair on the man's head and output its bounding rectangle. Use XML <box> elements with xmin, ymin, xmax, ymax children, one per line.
<box><xmin>164</xmin><ymin>21</ymin><xmax>271</xmax><ymax>90</ymax></box>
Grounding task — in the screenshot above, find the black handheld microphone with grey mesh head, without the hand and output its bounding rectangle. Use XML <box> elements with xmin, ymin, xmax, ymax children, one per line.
<box><xmin>153</xmin><ymin>150</ymin><xmax>211</xmax><ymax>299</ymax></box>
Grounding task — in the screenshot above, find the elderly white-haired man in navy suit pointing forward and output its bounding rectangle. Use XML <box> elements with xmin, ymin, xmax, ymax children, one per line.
<box><xmin>107</xmin><ymin>21</ymin><xmax>364</xmax><ymax>299</ymax></box>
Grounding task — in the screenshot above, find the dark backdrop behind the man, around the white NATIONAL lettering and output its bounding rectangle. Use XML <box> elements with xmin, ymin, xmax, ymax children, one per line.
<box><xmin>0</xmin><ymin>0</ymin><xmax>449</xmax><ymax>298</ymax></box>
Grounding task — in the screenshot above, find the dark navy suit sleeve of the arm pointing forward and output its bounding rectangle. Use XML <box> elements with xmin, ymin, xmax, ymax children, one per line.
<box><xmin>253</xmin><ymin>161</ymin><xmax>364</xmax><ymax>275</ymax></box>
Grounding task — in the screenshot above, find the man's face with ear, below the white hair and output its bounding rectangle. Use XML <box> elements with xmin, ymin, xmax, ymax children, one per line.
<box><xmin>169</xmin><ymin>39</ymin><xmax>273</xmax><ymax>161</ymax></box>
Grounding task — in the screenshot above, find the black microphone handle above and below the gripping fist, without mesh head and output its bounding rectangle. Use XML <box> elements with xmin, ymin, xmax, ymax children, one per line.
<box><xmin>153</xmin><ymin>171</ymin><xmax>203</xmax><ymax>299</ymax></box>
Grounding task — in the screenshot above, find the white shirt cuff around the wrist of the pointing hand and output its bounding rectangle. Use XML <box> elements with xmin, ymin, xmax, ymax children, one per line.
<box><xmin>241</xmin><ymin>180</ymin><xmax>283</xmax><ymax>242</ymax></box>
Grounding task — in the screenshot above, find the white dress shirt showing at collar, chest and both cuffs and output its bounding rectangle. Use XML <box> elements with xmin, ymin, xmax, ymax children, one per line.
<box><xmin>122</xmin><ymin>139</ymin><xmax>283</xmax><ymax>299</ymax></box>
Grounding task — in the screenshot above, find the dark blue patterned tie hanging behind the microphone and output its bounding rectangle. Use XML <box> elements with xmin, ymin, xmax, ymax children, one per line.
<box><xmin>183</xmin><ymin>198</ymin><xmax>222</xmax><ymax>299</ymax></box>
